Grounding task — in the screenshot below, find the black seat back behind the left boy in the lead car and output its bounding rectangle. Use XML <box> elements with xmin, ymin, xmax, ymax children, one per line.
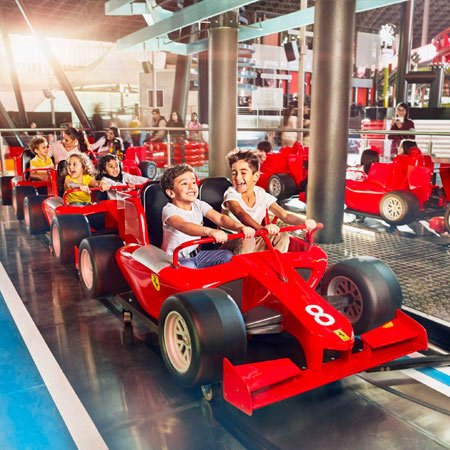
<box><xmin>141</xmin><ymin>181</ymin><xmax>169</xmax><ymax>247</ymax></box>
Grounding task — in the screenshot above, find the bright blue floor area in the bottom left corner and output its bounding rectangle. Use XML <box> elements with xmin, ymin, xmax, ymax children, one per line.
<box><xmin>0</xmin><ymin>293</ymin><xmax>76</xmax><ymax>450</ymax></box>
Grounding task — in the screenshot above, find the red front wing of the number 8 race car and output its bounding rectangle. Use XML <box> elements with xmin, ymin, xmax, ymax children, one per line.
<box><xmin>223</xmin><ymin>310</ymin><xmax>428</xmax><ymax>415</ymax></box>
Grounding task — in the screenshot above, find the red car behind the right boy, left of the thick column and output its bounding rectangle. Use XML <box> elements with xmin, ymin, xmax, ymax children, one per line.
<box><xmin>257</xmin><ymin>142</ymin><xmax>308</xmax><ymax>199</ymax></box>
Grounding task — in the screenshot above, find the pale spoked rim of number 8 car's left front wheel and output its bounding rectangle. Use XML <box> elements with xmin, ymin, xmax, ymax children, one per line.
<box><xmin>164</xmin><ymin>311</ymin><xmax>192</xmax><ymax>373</ymax></box>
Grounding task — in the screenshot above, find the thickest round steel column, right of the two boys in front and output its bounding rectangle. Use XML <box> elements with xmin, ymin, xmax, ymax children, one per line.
<box><xmin>307</xmin><ymin>0</ymin><xmax>355</xmax><ymax>243</ymax></box>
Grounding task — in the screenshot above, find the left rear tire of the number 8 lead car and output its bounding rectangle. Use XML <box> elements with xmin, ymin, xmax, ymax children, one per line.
<box><xmin>78</xmin><ymin>234</ymin><xmax>130</xmax><ymax>298</ymax></box>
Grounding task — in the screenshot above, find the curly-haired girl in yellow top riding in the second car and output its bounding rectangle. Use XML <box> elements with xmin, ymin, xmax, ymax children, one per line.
<box><xmin>64</xmin><ymin>153</ymin><xmax>104</xmax><ymax>205</ymax></box>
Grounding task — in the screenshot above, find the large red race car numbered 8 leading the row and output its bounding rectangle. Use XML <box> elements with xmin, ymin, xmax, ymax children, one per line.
<box><xmin>78</xmin><ymin>181</ymin><xmax>427</xmax><ymax>414</ymax></box>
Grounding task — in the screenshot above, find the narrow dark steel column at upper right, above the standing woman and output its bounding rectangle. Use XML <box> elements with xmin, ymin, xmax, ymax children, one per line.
<box><xmin>395</xmin><ymin>0</ymin><xmax>414</xmax><ymax>104</ymax></box>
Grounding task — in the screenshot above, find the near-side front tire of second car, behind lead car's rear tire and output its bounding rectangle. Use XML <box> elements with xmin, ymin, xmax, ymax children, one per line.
<box><xmin>50</xmin><ymin>214</ymin><xmax>91</xmax><ymax>264</ymax></box>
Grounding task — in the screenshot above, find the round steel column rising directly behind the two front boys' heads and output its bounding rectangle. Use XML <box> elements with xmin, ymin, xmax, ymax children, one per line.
<box><xmin>208</xmin><ymin>12</ymin><xmax>239</xmax><ymax>177</ymax></box>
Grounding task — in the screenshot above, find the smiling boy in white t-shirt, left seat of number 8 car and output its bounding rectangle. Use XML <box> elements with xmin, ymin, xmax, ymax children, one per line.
<box><xmin>160</xmin><ymin>164</ymin><xmax>255</xmax><ymax>269</ymax></box>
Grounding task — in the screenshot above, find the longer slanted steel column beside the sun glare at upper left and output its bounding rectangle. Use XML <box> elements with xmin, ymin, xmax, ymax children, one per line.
<box><xmin>16</xmin><ymin>0</ymin><xmax>94</xmax><ymax>129</ymax></box>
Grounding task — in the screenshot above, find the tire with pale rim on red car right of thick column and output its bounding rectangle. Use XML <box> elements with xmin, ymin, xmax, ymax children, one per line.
<box><xmin>380</xmin><ymin>191</ymin><xmax>420</xmax><ymax>225</ymax></box>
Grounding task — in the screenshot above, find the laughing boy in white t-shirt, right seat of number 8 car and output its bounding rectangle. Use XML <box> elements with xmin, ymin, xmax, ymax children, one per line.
<box><xmin>222</xmin><ymin>150</ymin><xmax>316</xmax><ymax>254</ymax></box>
